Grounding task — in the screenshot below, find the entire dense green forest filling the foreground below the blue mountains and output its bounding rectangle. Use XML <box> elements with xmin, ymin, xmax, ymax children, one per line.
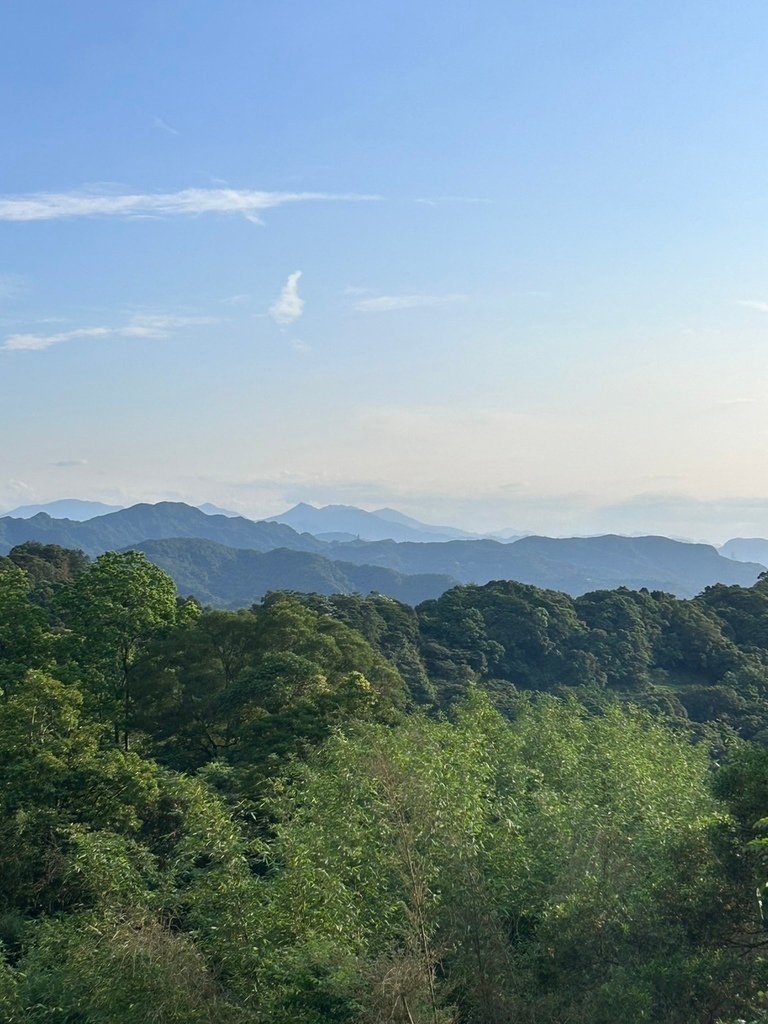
<box><xmin>0</xmin><ymin>543</ymin><xmax>768</xmax><ymax>1024</ymax></box>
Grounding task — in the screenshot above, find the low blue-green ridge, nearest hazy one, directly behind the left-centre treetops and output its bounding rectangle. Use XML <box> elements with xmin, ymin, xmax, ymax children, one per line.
<box><xmin>132</xmin><ymin>539</ymin><xmax>456</xmax><ymax>608</ymax></box>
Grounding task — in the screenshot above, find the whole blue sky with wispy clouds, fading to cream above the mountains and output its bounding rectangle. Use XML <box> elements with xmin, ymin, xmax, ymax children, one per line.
<box><xmin>0</xmin><ymin>0</ymin><xmax>768</xmax><ymax>543</ymax></box>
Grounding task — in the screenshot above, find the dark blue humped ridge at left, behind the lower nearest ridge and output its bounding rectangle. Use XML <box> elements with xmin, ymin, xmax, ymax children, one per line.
<box><xmin>0</xmin><ymin>502</ymin><xmax>326</xmax><ymax>555</ymax></box>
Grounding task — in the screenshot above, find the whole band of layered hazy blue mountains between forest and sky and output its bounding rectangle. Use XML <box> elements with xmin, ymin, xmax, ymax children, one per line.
<box><xmin>0</xmin><ymin>502</ymin><xmax>768</xmax><ymax>607</ymax></box>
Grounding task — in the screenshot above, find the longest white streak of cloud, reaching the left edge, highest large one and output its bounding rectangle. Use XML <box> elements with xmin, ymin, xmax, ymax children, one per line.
<box><xmin>0</xmin><ymin>188</ymin><xmax>381</xmax><ymax>221</ymax></box>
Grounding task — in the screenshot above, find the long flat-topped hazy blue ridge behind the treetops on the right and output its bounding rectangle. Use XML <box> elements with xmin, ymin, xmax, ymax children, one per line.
<box><xmin>330</xmin><ymin>536</ymin><xmax>763</xmax><ymax>597</ymax></box>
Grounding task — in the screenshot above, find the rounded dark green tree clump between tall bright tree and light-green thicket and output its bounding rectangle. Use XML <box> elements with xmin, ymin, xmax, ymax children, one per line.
<box><xmin>136</xmin><ymin>595</ymin><xmax>406</xmax><ymax>787</ymax></box>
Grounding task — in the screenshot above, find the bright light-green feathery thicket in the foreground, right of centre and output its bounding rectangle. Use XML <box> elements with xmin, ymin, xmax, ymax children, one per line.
<box><xmin>249</xmin><ymin>696</ymin><xmax>753</xmax><ymax>1024</ymax></box>
